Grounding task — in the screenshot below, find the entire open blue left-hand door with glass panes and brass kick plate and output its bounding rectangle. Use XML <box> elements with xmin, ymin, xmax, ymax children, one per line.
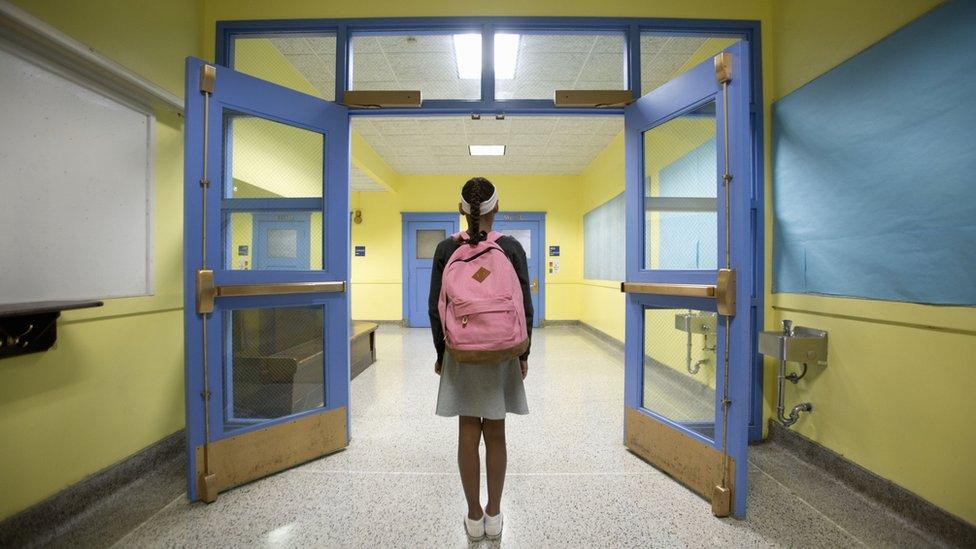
<box><xmin>184</xmin><ymin>58</ymin><xmax>349</xmax><ymax>502</ymax></box>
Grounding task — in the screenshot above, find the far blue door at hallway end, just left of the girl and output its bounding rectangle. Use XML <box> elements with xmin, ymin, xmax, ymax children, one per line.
<box><xmin>403</xmin><ymin>213</ymin><xmax>460</xmax><ymax>328</ymax></box>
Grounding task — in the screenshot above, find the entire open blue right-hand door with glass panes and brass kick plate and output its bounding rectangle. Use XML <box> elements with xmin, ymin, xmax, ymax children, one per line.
<box><xmin>621</xmin><ymin>42</ymin><xmax>762</xmax><ymax>517</ymax></box>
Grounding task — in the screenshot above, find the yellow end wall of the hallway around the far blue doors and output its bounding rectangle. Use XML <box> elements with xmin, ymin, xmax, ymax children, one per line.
<box><xmin>352</xmin><ymin>175</ymin><xmax>582</xmax><ymax>320</ymax></box>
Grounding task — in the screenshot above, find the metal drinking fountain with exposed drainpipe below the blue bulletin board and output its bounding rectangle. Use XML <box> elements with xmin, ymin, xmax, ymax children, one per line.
<box><xmin>759</xmin><ymin>320</ymin><xmax>827</xmax><ymax>427</ymax></box>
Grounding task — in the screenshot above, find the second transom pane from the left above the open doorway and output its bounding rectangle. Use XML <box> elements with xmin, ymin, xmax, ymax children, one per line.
<box><xmin>350</xmin><ymin>32</ymin><xmax>481</xmax><ymax>100</ymax></box>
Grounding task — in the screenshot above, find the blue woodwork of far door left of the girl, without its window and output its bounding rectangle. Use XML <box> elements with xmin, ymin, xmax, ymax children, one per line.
<box><xmin>401</xmin><ymin>212</ymin><xmax>461</xmax><ymax>328</ymax></box>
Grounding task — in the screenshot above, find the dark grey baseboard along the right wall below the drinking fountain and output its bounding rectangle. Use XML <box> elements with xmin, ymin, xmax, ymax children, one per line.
<box><xmin>768</xmin><ymin>419</ymin><xmax>976</xmax><ymax>547</ymax></box>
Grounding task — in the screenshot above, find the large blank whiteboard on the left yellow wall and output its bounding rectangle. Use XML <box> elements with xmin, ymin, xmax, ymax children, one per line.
<box><xmin>0</xmin><ymin>43</ymin><xmax>154</xmax><ymax>304</ymax></box>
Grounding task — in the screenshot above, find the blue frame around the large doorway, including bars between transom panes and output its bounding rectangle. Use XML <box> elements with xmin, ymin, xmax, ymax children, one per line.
<box><xmin>214</xmin><ymin>17</ymin><xmax>765</xmax><ymax>441</ymax></box>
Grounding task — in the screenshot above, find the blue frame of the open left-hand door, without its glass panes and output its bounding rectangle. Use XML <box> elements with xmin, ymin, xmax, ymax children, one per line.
<box><xmin>184</xmin><ymin>58</ymin><xmax>350</xmax><ymax>500</ymax></box>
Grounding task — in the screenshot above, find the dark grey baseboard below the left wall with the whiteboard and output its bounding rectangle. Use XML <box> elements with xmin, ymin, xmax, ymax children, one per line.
<box><xmin>0</xmin><ymin>429</ymin><xmax>186</xmax><ymax>547</ymax></box>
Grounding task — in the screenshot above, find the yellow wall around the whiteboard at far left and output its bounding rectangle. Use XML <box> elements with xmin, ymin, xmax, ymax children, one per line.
<box><xmin>0</xmin><ymin>0</ymin><xmax>201</xmax><ymax>518</ymax></box>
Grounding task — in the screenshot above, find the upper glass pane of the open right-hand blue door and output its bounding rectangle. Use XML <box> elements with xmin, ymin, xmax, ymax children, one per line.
<box><xmin>644</xmin><ymin>102</ymin><xmax>718</xmax><ymax>270</ymax></box>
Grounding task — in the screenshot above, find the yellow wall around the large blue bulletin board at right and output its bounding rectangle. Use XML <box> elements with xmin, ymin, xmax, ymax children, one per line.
<box><xmin>766</xmin><ymin>0</ymin><xmax>976</xmax><ymax>523</ymax></box>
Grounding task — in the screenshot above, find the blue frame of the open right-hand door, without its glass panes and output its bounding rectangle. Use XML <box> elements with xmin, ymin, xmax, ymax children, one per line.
<box><xmin>624</xmin><ymin>43</ymin><xmax>762</xmax><ymax>517</ymax></box>
